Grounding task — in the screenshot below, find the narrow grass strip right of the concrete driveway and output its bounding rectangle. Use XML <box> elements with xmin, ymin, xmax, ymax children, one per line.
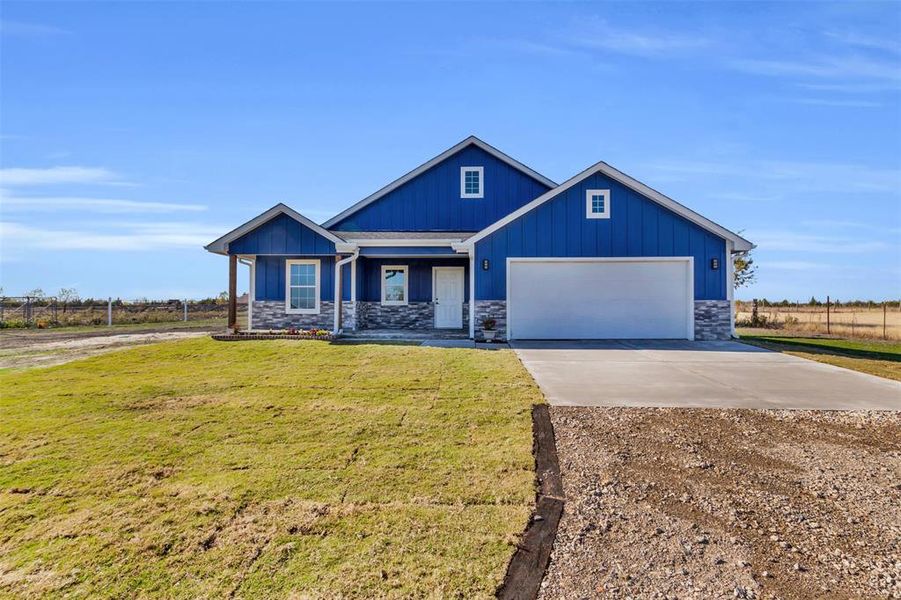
<box><xmin>738</xmin><ymin>330</ymin><xmax>901</xmax><ymax>381</ymax></box>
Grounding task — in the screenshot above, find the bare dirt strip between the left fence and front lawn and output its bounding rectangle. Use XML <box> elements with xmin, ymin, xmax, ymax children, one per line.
<box><xmin>0</xmin><ymin>330</ymin><xmax>208</xmax><ymax>368</ymax></box>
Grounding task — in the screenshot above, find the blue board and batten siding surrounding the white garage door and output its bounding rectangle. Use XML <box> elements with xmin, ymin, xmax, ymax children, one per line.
<box><xmin>475</xmin><ymin>173</ymin><xmax>726</xmax><ymax>300</ymax></box>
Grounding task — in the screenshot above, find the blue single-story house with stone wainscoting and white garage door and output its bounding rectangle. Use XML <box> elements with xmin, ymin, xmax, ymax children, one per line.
<box><xmin>206</xmin><ymin>137</ymin><xmax>754</xmax><ymax>339</ymax></box>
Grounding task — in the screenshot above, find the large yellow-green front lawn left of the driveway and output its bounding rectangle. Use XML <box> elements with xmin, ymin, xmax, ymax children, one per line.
<box><xmin>0</xmin><ymin>338</ymin><xmax>541</xmax><ymax>598</ymax></box>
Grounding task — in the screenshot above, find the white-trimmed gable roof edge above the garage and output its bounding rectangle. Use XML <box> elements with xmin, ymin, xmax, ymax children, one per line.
<box><xmin>465</xmin><ymin>161</ymin><xmax>754</xmax><ymax>252</ymax></box>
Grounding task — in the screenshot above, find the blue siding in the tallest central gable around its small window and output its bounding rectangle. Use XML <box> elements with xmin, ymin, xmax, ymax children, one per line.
<box><xmin>331</xmin><ymin>145</ymin><xmax>549</xmax><ymax>232</ymax></box>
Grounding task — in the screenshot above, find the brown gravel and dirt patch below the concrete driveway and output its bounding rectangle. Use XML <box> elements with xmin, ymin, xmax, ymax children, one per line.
<box><xmin>540</xmin><ymin>407</ymin><xmax>901</xmax><ymax>598</ymax></box>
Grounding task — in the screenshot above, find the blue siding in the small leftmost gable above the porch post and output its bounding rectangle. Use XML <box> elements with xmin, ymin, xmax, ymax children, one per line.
<box><xmin>228</xmin><ymin>214</ymin><xmax>335</xmax><ymax>256</ymax></box>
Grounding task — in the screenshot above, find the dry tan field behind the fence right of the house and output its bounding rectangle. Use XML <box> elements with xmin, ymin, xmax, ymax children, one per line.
<box><xmin>735</xmin><ymin>302</ymin><xmax>901</xmax><ymax>340</ymax></box>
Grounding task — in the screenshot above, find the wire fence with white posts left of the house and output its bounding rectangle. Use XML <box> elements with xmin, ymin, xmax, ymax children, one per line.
<box><xmin>0</xmin><ymin>296</ymin><xmax>239</xmax><ymax>328</ymax></box>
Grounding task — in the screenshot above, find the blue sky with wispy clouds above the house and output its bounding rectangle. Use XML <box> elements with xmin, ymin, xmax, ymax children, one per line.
<box><xmin>0</xmin><ymin>1</ymin><xmax>901</xmax><ymax>299</ymax></box>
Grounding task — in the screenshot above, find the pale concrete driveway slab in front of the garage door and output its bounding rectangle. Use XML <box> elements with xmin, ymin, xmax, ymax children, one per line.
<box><xmin>510</xmin><ymin>340</ymin><xmax>901</xmax><ymax>410</ymax></box>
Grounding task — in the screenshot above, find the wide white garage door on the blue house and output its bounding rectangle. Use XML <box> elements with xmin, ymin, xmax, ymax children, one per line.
<box><xmin>507</xmin><ymin>258</ymin><xmax>694</xmax><ymax>340</ymax></box>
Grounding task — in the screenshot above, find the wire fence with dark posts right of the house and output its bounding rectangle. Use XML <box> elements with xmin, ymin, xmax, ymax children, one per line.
<box><xmin>735</xmin><ymin>297</ymin><xmax>901</xmax><ymax>340</ymax></box>
